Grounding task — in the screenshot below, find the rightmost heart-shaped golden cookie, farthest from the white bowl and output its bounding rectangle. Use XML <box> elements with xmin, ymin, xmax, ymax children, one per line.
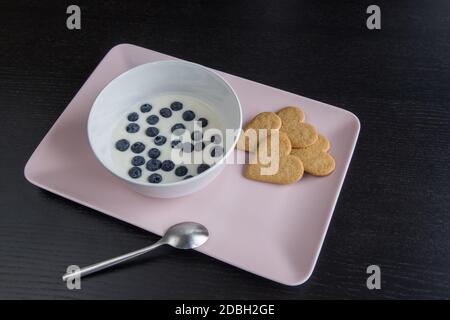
<box><xmin>291</xmin><ymin>134</ymin><xmax>336</xmax><ymax>176</ymax></box>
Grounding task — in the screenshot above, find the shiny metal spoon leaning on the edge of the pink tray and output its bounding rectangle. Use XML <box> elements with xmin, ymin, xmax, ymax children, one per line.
<box><xmin>63</xmin><ymin>222</ymin><xmax>209</xmax><ymax>281</ymax></box>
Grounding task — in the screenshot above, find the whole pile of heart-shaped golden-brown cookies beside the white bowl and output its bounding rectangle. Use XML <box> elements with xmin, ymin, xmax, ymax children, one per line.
<box><xmin>237</xmin><ymin>106</ymin><xmax>336</xmax><ymax>184</ymax></box>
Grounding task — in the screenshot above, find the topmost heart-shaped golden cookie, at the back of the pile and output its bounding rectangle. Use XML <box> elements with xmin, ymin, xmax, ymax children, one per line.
<box><xmin>277</xmin><ymin>107</ymin><xmax>317</xmax><ymax>148</ymax></box>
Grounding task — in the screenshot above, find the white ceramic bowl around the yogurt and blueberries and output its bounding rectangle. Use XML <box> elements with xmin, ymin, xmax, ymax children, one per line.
<box><xmin>87</xmin><ymin>60</ymin><xmax>242</xmax><ymax>198</ymax></box>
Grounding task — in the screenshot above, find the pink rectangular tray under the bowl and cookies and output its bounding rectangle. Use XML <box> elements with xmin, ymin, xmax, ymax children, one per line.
<box><xmin>25</xmin><ymin>44</ymin><xmax>360</xmax><ymax>285</ymax></box>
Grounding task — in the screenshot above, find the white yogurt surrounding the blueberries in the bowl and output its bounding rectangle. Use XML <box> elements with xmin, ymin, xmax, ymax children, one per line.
<box><xmin>111</xmin><ymin>94</ymin><xmax>225</xmax><ymax>184</ymax></box>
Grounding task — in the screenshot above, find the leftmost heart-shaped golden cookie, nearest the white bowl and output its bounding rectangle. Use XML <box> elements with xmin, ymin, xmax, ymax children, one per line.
<box><xmin>236</xmin><ymin>112</ymin><xmax>281</xmax><ymax>152</ymax></box>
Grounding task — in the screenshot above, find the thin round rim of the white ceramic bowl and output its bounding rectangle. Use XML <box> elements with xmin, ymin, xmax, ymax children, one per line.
<box><xmin>86</xmin><ymin>60</ymin><xmax>242</xmax><ymax>188</ymax></box>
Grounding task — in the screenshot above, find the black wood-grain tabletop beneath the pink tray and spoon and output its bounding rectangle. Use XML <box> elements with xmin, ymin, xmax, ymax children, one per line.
<box><xmin>0</xmin><ymin>0</ymin><xmax>450</xmax><ymax>299</ymax></box>
